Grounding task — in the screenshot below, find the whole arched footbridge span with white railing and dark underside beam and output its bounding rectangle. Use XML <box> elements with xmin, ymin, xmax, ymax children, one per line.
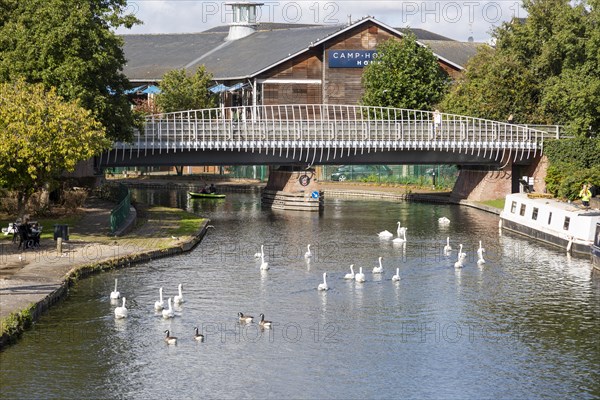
<box><xmin>99</xmin><ymin>104</ymin><xmax>558</xmax><ymax>167</ymax></box>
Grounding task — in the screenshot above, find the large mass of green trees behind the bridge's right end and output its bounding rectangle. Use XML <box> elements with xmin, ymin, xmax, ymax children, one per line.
<box><xmin>442</xmin><ymin>0</ymin><xmax>600</xmax><ymax>136</ymax></box>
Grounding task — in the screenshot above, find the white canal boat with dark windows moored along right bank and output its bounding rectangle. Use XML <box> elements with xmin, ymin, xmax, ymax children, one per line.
<box><xmin>500</xmin><ymin>193</ymin><xmax>600</xmax><ymax>256</ymax></box>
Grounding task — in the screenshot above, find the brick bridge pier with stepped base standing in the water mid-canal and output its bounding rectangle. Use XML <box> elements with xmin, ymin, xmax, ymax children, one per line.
<box><xmin>262</xmin><ymin>167</ymin><xmax>323</xmax><ymax>211</ymax></box>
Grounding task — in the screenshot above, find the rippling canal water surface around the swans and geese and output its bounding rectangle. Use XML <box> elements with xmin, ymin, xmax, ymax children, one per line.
<box><xmin>0</xmin><ymin>191</ymin><xmax>600</xmax><ymax>399</ymax></box>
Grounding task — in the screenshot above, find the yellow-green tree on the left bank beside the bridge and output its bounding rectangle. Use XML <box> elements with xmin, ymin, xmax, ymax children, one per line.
<box><xmin>0</xmin><ymin>80</ymin><xmax>111</xmax><ymax>215</ymax></box>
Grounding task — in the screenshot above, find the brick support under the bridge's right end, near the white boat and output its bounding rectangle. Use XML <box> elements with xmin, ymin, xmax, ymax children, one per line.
<box><xmin>451</xmin><ymin>156</ymin><xmax>548</xmax><ymax>201</ymax></box>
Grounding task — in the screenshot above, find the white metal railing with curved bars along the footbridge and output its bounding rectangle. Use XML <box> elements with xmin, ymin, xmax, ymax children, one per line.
<box><xmin>108</xmin><ymin>104</ymin><xmax>558</xmax><ymax>163</ymax></box>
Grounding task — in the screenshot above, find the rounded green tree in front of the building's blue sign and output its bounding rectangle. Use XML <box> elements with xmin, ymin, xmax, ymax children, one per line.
<box><xmin>361</xmin><ymin>33</ymin><xmax>449</xmax><ymax>110</ymax></box>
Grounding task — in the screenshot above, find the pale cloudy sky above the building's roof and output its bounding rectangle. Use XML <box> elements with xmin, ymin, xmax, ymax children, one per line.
<box><xmin>117</xmin><ymin>0</ymin><xmax>526</xmax><ymax>42</ymax></box>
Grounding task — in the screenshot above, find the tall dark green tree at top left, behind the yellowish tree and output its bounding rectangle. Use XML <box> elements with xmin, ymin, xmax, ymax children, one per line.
<box><xmin>0</xmin><ymin>0</ymin><xmax>139</xmax><ymax>140</ymax></box>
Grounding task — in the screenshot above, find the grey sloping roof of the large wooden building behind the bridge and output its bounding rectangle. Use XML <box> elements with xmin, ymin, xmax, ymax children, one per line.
<box><xmin>122</xmin><ymin>17</ymin><xmax>482</xmax><ymax>82</ymax></box>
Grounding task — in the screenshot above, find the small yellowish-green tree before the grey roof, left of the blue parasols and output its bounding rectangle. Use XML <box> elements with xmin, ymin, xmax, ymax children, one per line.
<box><xmin>156</xmin><ymin>65</ymin><xmax>217</xmax><ymax>112</ymax></box>
